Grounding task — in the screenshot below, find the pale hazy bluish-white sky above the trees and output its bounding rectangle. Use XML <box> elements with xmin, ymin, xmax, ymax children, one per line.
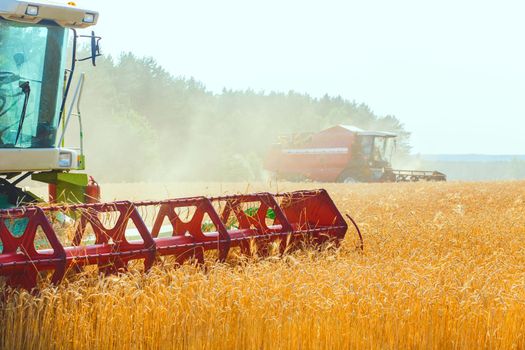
<box><xmin>80</xmin><ymin>0</ymin><xmax>525</xmax><ymax>154</ymax></box>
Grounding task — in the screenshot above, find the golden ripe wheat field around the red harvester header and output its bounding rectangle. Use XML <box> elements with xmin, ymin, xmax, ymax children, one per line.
<box><xmin>0</xmin><ymin>182</ymin><xmax>525</xmax><ymax>349</ymax></box>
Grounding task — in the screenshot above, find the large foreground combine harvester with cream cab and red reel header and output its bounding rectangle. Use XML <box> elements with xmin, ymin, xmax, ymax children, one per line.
<box><xmin>0</xmin><ymin>0</ymin><xmax>347</xmax><ymax>290</ymax></box>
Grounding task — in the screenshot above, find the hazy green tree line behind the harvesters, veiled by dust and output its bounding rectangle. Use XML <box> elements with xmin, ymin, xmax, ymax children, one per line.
<box><xmin>69</xmin><ymin>53</ymin><xmax>410</xmax><ymax>181</ymax></box>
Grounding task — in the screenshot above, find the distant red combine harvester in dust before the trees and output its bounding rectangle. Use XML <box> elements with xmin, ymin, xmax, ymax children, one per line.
<box><xmin>265</xmin><ymin>125</ymin><xmax>447</xmax><ymax>183</ymax></box>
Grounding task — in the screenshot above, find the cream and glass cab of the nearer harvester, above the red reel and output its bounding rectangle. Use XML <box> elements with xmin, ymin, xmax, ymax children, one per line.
<box><xmin>0</xmin><ymin>0</ymin><xmax>100</xmax><ymax>208</ymax></box>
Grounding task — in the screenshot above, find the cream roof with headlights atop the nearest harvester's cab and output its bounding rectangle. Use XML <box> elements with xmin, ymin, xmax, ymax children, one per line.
<box><xmin>0</xmin><ymin>0</ymin><xmax>98</xmax><ymax>28</ymax></box>
